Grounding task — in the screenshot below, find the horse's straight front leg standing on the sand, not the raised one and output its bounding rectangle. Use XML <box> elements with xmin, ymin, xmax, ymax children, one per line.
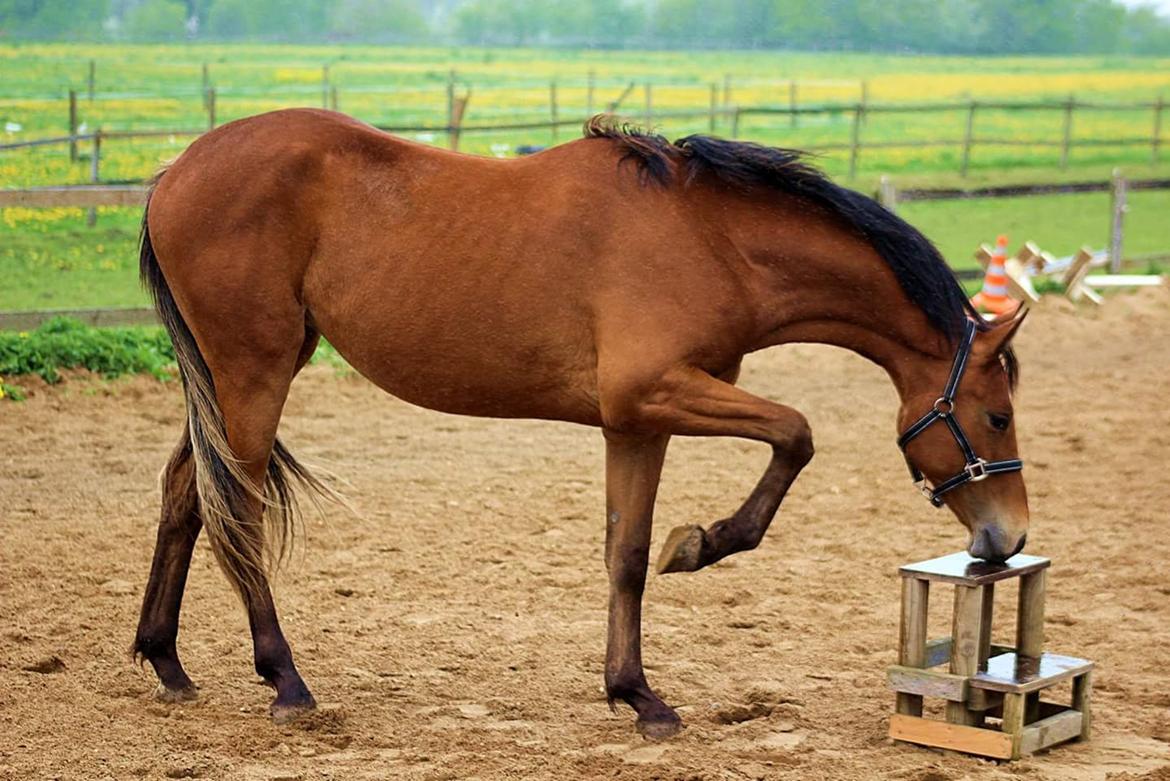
<box><xmin>605</xmin><ymin>430</ymin><xmax>682</xmax><ymax>739</ymax></box>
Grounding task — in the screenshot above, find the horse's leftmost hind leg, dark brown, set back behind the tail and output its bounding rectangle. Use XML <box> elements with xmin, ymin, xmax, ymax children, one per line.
<box><xmin>131</xmin><ymin>426</ymin><xmax>202</xmax><ymax>701</ymax></box>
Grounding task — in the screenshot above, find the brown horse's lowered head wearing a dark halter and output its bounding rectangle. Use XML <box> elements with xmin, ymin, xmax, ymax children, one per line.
<box><xmin>899</xmin><ymin>312</ymin><xmax>1028</xmax><ymax>561</ymax></box>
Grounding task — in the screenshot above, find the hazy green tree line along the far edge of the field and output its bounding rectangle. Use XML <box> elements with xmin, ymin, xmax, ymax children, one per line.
<box><xmin>0</xmin><ymin>0</ymin><xmax>1170</xmax><ymax>55</ymax></box>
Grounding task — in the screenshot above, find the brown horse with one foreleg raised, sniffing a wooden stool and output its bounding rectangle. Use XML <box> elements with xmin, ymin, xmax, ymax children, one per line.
<box><xmin>133</xmin><ymin>110</ymin><xmax>1027</xmax><ymax>735</ymax></box>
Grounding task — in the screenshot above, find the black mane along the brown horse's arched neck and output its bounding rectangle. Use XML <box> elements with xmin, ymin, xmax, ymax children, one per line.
<box><xmin>585</xmin><ymin>115</ymin><xmax>1017</xmax><ymax>383</ymax></box>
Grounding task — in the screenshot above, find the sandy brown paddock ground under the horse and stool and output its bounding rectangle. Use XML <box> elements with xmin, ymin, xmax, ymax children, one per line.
<box><xmin>0</xmin><ymin>291</ymin><xmax>1170</xmax><ymax>781</ymax></box>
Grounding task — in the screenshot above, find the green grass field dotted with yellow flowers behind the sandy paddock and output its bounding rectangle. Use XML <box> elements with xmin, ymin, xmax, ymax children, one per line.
<box><xmin>0</xmin><ymin>44</ymin><xmax>1170</xmax><ymax>310</ymax></box>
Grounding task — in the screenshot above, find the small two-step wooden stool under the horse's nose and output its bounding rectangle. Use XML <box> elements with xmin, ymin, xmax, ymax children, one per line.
<box><xmin>889</xmin><ymin>553</ymin><xmax>1093</xmax><ymax>759</ymax></box>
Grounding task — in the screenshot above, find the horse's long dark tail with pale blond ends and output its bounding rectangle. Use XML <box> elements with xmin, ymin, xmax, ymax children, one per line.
<box><xmin>139</xmin><ymin>179</ymin><xmax>337</xmax><ymax>599</ymax></box>
